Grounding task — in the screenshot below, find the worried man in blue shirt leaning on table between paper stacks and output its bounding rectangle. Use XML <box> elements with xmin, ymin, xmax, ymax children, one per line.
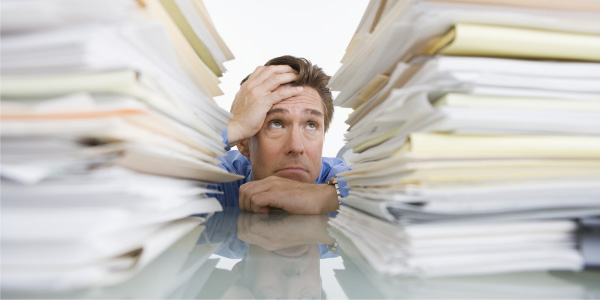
<box><xmin>215</xmin><ymin>56</ymin><xmax>348</xmax><ymax>214</ymax></box>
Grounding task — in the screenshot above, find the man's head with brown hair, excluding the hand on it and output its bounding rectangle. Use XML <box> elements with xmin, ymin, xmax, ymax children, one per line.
<box><xmin>238</xmin><ymin>56</ymin><xmax>333</xmax><ymax>183</ymax></box>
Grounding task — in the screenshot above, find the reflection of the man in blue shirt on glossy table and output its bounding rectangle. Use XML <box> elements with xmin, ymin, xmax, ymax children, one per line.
<box><xmin>201</xmin><ymin>210</ymin><xmax>336</xmax><ymax>299</ymax></box>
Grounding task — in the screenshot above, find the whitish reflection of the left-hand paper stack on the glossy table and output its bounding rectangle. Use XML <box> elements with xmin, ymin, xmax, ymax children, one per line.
<box><xmin>3</xmin><ymin>217</ymin><xmax>219</xmax><ymax>299</ymax></box>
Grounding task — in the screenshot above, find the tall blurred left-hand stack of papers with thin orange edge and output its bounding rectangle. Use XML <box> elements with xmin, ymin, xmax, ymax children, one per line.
<box><xmin>0</xmin><ymin>0</ymin><xmax>240</xmax><ymax>293</ymax></box>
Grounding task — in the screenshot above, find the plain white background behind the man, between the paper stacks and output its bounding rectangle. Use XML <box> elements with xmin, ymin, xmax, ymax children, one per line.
<box><xmin>204</xmin><ymin>0</ymin><xmax>368</xmax><ymax>157</ymax></box>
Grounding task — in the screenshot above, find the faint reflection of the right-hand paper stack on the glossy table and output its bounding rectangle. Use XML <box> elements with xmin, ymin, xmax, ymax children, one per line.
<box><xmin>330</xmin><ymin>228</ymin><xmax>599</xmax><ymax>299</ymax></box>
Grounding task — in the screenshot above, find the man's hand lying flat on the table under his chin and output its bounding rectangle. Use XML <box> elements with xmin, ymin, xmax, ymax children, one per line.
<box><xmin>239</xmin><ymin>176</ymin><xmax>339</xmax><ymax>215</ymax></box>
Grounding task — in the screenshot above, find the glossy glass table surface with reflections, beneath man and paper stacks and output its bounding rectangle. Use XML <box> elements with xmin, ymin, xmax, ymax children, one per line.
<box><xmin>2</xmin><ymin>210</ymin><xmax>600</xmax><ymax>299</ymax></box>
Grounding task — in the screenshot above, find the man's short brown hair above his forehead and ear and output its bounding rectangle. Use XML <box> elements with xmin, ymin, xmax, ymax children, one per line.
<box><xmin>240</xmin><ymin>55</ymin><xmax>333</xmax><ymax>132</ymax></box>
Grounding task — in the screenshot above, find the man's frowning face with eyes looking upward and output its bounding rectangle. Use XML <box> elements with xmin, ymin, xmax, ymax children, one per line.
<box><xmin>238</xmin><ymin>87</ymin><xmax>325</xmax><ymax>183</ymax></box>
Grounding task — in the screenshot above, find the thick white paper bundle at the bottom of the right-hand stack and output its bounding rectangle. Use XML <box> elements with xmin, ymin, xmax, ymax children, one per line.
<box><xmin>331</xmin><ymin>207</ymin><xmax>582</xmax><ymax>276</ymax></box>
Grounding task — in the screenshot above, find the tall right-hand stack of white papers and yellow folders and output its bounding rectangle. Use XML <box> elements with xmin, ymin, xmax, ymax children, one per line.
<box><xmin>330</xmin><ymin>0</ymin><xmax>600</xmax><ymax>276</ymax></box>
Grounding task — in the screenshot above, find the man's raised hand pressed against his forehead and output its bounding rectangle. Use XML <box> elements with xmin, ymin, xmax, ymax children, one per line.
<box><xmin>227</xmin><ymin>65</ymin><xmax>302</xmax><ymax>146</ymax></box>
